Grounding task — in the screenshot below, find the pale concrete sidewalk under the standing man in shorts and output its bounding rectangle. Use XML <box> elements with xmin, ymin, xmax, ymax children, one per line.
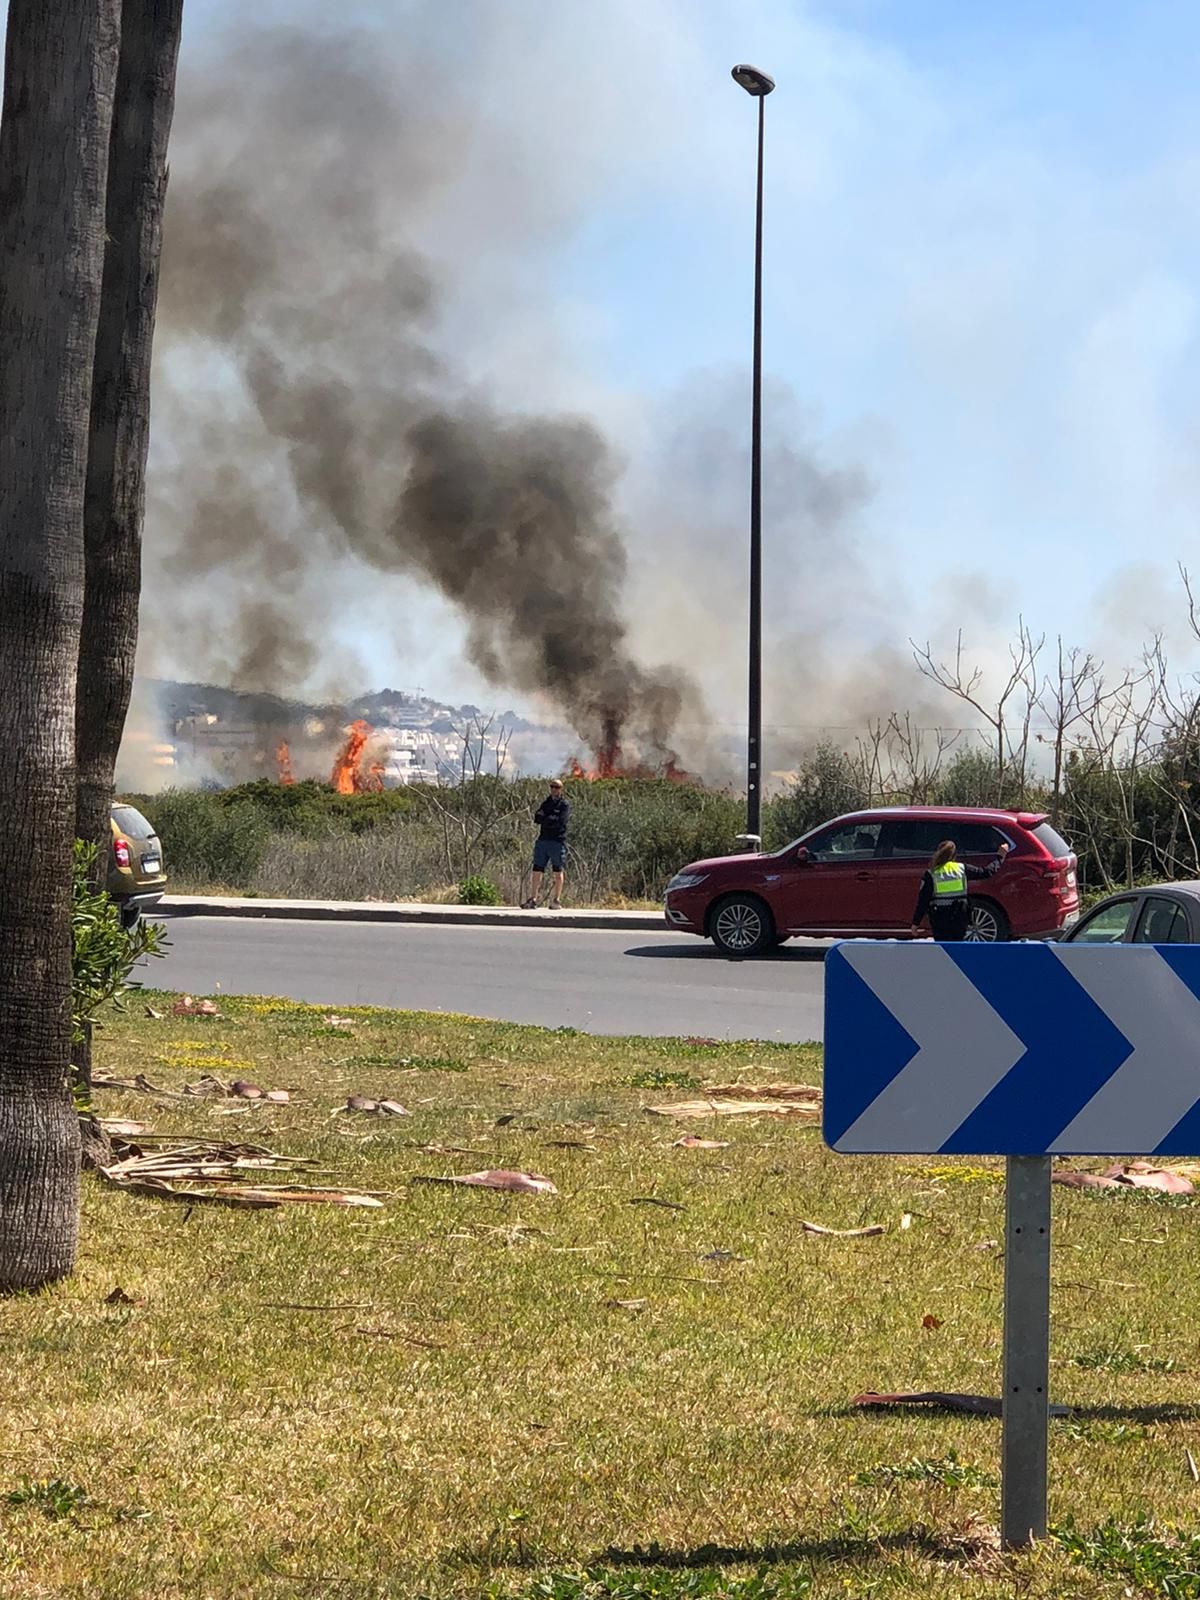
<box><xmin>158</xmin><ymin>894</ymin><xmax>670</xmax><ymax>933</ymax></box>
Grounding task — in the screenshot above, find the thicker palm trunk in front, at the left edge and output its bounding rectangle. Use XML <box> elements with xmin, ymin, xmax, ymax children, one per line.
<box><xmin>0</xmin><ymin>0</ymin><xmax>120</xmax><ymax>1290</ymax></box>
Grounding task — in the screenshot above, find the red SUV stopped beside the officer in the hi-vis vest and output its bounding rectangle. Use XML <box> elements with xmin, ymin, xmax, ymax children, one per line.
<box><xmin>666</xmin><ymin>805</ymin><xmax>1078</xmax><ymax>955</ymax></box>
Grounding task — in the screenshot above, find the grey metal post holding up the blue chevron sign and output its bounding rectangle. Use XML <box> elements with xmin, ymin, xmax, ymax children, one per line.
<box><xmin>1000</xmin><ymin>1155</ymin><xmax>1050</xmax><ymax>1549</ymax></box>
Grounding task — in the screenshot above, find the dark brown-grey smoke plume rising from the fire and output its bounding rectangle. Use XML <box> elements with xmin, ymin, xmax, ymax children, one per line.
<box><xmin>149</xmin><ymin>18</ymin><xmax>698</xmax><ymax>752</ymax></box>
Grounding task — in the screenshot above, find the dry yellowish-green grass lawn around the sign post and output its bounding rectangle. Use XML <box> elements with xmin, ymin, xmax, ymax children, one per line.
<box><xmin>0</xmin><ymin>997</ymin><xmax>1200</xmax><ymax>1600</ymax></box>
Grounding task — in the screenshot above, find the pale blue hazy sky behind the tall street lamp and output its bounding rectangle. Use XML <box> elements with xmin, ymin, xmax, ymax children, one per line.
<box><xmin>150</xmin><ymin>0</ymin><xmax>1200</xmax><ymax>736</ymax></box>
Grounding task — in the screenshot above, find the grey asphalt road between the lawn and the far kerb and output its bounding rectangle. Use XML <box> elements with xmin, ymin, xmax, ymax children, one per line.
<box><xmin>144</xmin><ymin>917</ymin><xmax>824</xmax><ymax>1042</ymax></box>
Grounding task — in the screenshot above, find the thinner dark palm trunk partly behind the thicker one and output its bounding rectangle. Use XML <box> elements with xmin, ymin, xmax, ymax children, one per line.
<box><xmin>72</xmin><ymin>0</ymin><xmax>182</xmax><ymax>1132</ymax></box>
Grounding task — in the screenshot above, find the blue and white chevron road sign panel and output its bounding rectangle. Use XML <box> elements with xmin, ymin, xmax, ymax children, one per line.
<box><xmin>824</xmin><ymin>939</ymin><xmax>1200</xmax><ymax>1155</ymax></box>
